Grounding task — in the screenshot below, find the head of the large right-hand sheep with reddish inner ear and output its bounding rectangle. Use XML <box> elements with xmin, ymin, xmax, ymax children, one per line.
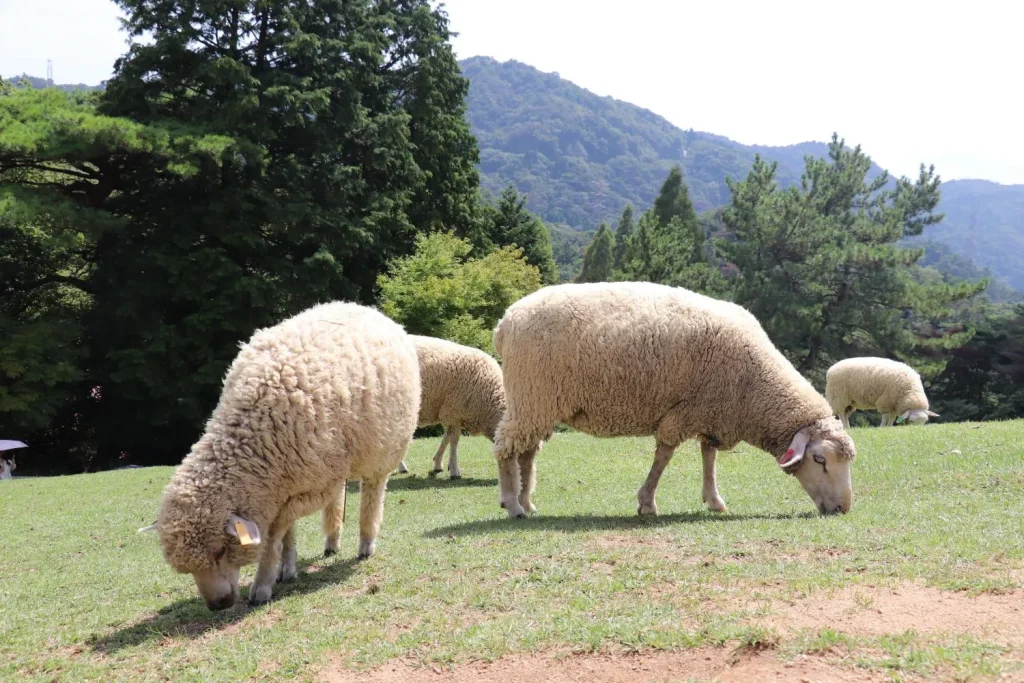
<box><xmin>778</xmin><ymin>418</ymin><xmax>857</xmax><ymax>515</ymax></box>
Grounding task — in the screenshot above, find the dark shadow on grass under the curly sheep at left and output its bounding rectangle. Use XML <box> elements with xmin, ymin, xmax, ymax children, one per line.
<box><xmin>86</xmin><ymin>557</ymin><xmax>359</xmax><ymax>654</ymax></box>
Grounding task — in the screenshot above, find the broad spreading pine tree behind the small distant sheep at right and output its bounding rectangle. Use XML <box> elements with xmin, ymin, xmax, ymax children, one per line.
<box><xmin>720</xmin><ymin>136</ymin><xmax>985</xmax><ymax>380</ymax></box>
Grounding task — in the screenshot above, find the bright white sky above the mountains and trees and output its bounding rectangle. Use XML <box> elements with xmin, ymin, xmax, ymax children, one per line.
<box><xmin>0</xmin><ymin>0</ymin><xmax>1024</xmax><ymax>183</ymax></box>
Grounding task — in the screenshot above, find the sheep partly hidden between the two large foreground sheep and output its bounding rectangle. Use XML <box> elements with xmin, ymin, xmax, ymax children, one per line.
<box><xmin>398</xmin><ymin>335</ymin><xmax>505</xmax><ymax>479</ymax></box>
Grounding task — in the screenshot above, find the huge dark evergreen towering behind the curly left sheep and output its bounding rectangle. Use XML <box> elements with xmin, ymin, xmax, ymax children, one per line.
<box><xmin>46</xmin><ymin>0</ymin><xmax>479</xmax><ymax>462</ymax></box>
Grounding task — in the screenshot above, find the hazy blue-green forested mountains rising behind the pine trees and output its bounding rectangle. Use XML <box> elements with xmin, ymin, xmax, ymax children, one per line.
<box><xmin>460</xmin><ymin>57</ymin><xmax>1024</xmax><ymax>291</ymax></box>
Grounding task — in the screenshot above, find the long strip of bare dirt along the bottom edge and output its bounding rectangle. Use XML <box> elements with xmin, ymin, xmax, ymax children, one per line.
<box><xmin>318</xmin><ymin>648</ymin><xmax>887</xmax><ymax>683</ymax></box>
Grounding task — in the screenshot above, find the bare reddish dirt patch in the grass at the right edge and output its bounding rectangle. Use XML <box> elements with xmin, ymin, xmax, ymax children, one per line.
<box><xmin>770</xmin><ymin>584</ymin><xmax>1024</xmax><ymax>646</ymax></box>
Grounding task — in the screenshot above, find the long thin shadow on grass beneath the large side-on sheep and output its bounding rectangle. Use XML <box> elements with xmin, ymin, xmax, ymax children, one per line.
<box><xmin>423</xmin><ymin>511</ymin><xmax>818</xmax><ymax>539</ymax></box>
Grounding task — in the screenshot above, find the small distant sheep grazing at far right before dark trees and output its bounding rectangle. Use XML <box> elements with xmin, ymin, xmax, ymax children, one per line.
<box><xmin>825</xmin><ymin>356</ymin><xmax>939</xmax><ymax>429</ymax></box>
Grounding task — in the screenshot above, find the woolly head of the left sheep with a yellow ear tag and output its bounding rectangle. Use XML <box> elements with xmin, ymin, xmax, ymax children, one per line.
<box><xmin>154</xmin><ymin>483</ymin><xmax>262</xmax><ymax>610</ymax></box>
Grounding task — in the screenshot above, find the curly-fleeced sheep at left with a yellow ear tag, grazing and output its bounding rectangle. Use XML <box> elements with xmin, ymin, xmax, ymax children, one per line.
<box><xmin>144</xmin><ymin>302</ymin><xmax>420</xmax><ymax>610</ymax></box>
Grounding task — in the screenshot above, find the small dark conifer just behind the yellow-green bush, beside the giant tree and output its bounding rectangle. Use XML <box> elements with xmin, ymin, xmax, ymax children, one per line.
<box><xmin>483</xmin><ymin>185</ymin><xmax>558</xmax><ymax>285</ymax></box>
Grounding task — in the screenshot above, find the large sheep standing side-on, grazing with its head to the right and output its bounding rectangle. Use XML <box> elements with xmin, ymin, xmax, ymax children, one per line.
<box><xmin>494</xmin><ymin>283</ymin><xmax>856</xmax><ymax>517</ymax></box>
